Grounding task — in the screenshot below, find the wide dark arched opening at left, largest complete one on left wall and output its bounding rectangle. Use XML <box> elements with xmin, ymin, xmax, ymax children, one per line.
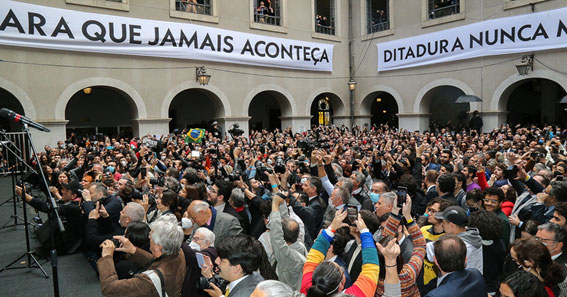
<box><xmin>65</xmin><ymin>86</ymin><xmax>138</xmax><ymax>137</ymax></box>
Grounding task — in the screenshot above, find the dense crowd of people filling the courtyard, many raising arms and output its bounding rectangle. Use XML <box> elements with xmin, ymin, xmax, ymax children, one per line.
<box><xmin>4</xmin><ymin>121</ymin><xmax>567</xmax><ymax>297</ymax></box>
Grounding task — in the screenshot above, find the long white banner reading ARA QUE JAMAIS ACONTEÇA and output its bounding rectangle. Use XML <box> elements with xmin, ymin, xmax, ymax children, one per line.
<box><xmin>0</xmin><ymin>0</ymin><xmax>333</xmax><ymax>71</ymax></box>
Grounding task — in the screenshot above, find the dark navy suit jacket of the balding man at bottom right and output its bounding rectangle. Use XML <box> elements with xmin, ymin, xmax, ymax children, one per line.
<box><xmin>425</xmin><ymin>269</ymin><xmax>488</xmax><ymax>297</ymax></box>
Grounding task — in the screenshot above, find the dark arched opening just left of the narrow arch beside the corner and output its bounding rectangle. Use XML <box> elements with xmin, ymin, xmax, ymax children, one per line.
<box><xmin>248</xmin><ymin>91</ymin><xmax>291</xmax><ymax>131</ymax></box>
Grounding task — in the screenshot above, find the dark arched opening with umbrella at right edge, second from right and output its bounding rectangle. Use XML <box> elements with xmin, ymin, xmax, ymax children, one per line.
<box><xmin>421</xmin><ymin>86</ymin><xmax>470</xmax><ymax>129</ymax></box>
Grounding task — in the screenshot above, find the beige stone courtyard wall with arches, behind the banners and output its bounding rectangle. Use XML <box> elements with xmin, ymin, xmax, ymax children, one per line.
<box><xmin>0</xmin><ymin>0</ymin><xmax>567</xmax><ymax>143</ymax></box>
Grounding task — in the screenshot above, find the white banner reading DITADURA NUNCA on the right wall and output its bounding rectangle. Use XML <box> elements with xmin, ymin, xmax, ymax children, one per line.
<box><xmin>376</xmin><ymin>8</ymin><xmax>567</xmax><ymax>71</ymax></box>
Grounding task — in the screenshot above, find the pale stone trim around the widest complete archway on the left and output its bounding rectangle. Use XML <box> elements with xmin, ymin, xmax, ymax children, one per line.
<box><xmin>55</xmin><ymin>77</ymin><xmax>148</xmax><ymax>120</ymax></box>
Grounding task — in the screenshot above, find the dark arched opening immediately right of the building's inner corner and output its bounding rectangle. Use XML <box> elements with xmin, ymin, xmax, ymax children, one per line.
<box><xmin>363</xmin><ymin>91</ymin><xmax>399</xmax><ymax>127</ymax></box>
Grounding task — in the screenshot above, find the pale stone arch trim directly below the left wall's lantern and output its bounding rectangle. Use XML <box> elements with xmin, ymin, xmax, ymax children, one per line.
<box><xmin>161</xmin><ymin>81</ymin><xmax>232</xmax><ymax>118</ymax></box>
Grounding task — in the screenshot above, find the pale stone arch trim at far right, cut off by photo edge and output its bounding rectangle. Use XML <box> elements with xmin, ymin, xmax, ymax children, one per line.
<box><xmin>490</xmin><ymin>70</ymin><xmax>567</xmax><ymax>111</ymax></box>
